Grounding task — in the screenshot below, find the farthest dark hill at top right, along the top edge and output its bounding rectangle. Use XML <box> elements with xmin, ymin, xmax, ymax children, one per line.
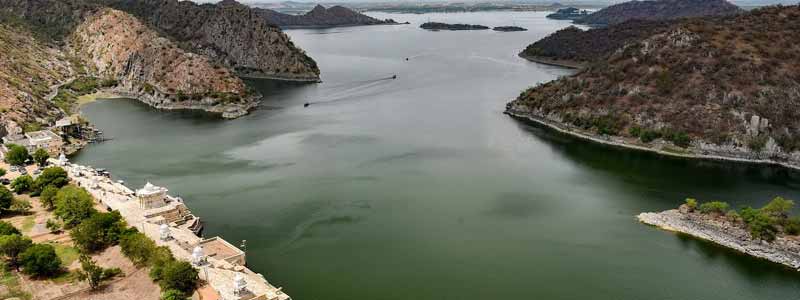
<box><xmin>575</xmin><ymin>0</ymin><xmax>741</xmax><ymax>25</ymax></box>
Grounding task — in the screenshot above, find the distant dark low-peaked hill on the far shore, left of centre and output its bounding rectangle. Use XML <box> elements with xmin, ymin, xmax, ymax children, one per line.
<box><xmin>254</xmin><ymin>5</ymin><xmax>397</xmax><ymax>27</ymax></box>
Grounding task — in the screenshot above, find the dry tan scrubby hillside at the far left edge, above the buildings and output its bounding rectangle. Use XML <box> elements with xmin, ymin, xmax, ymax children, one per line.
<box><xmin>0</xmin><ymin>24</ymin><xmax>71</xmax><ymax>134</ymax></box>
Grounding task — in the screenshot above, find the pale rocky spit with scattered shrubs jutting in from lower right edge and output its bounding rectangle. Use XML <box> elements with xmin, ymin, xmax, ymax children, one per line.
<box><xmin>637</xmin><ymin>199</ymin><xmax>800</xmax><ymax>271</ymax></box>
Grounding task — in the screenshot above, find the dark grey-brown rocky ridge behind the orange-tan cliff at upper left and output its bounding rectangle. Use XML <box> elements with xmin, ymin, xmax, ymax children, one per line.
<box><xmin>103</xmin><ymin>0</ymin><xmax>319</xmax><ymax>81</ymax></box>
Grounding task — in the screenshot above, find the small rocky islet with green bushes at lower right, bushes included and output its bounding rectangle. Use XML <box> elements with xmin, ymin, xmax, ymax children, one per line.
<box><xmin>637</xmin><ymin>197</ymin><xmax>800</xmax><ymax>271</ymax></box>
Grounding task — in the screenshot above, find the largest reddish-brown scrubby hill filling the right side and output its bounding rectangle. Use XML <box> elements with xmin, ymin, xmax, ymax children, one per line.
<box><xmin>507</xmin><ymin>6</ymin><xmax>800</xmax><ymax>167</ymax></box>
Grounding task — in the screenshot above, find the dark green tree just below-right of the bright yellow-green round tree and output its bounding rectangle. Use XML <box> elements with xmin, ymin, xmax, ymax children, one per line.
<box><xmin>70</xmin><ymin>211</ymin><xmax>125</xmax><ymax>253</ymax></box>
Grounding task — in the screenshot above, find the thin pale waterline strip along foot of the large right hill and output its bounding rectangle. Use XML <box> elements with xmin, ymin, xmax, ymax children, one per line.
<box><xmin>503</xmin><ymin>110</ymin><xmax>800</xmax><ymax>171</ymax></box>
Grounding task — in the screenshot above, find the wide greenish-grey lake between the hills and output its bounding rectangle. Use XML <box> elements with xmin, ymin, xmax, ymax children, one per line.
<box><xmin>73</xmin><ymin>12</ymin><xmax>800</xmax><ymax>300</ymax></box>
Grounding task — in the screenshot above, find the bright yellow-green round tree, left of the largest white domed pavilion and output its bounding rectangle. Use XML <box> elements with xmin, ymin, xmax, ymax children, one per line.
<box><xmin>53</xmin><ymin>185</ymin><xmax>95</xmax><ymax>228</ymax></box>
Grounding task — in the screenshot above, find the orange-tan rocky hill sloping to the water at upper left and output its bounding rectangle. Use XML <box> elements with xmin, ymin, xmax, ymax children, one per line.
<box><xmin>69</xmin><ymin>8</ymin><xmax>256</xmax><ymax>116</ymax></box>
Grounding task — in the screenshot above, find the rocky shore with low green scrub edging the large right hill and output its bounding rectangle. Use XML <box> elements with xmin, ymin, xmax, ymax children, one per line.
<box><xmin>503</xmin><ymin>108</ymin><xmax>800</xmax><ymax>170</ymax></box>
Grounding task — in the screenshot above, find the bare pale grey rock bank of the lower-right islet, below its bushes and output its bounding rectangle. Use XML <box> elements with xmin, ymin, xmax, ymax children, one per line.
<box><xmin>637</xmin><ymin>209</ymin><xmax>800</xmax><ymax>271</ymax></box>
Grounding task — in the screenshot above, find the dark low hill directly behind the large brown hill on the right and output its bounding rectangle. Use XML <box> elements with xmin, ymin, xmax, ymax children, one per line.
<box><xmin>519</xmin><ymin>20</ymin><xmax>670</xmax><ymax>67</ymax></box>
